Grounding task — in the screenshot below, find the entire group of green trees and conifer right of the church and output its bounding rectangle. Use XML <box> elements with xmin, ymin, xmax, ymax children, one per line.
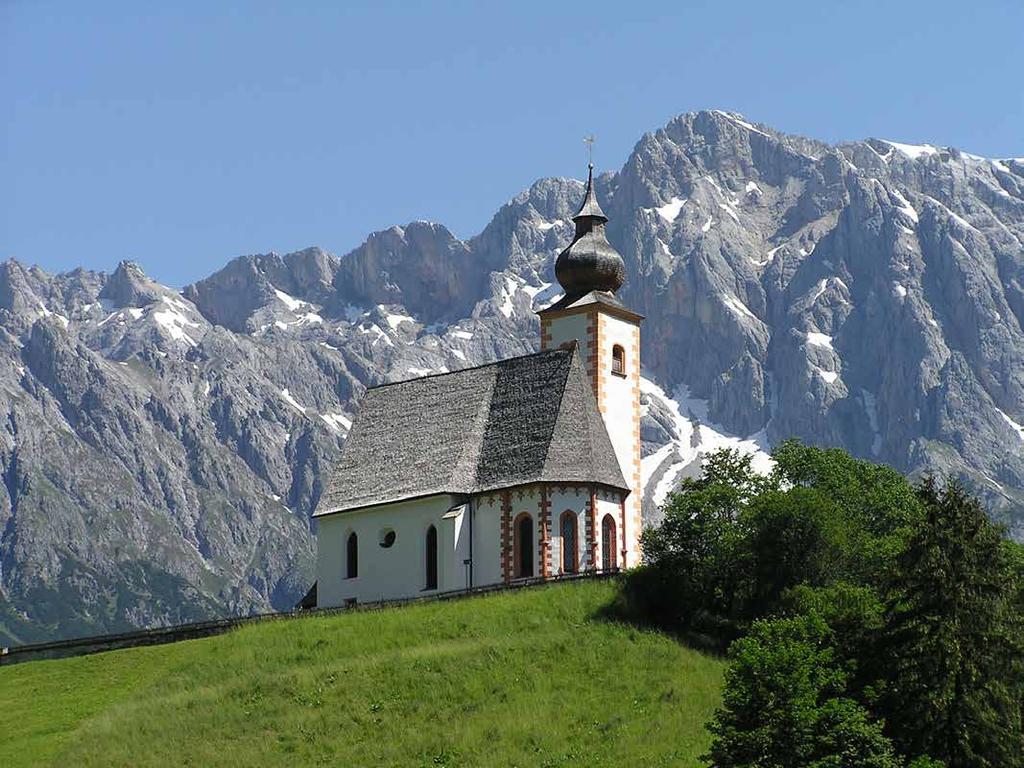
<box><xmin>623</xmin><ymin>441</ymin><xmax>1024</xmax><ymax>768</ymax></box>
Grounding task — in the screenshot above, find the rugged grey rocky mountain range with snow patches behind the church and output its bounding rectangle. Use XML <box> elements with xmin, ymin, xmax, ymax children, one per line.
<box><xmin>0</xmin><ymin>112</ymin><xmax>1024</xmax><ymax>643</ymax></box>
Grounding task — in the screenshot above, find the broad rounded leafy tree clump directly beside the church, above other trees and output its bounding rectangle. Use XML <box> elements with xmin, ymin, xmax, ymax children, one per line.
<box><xmin>625</xmin><ymin>441</ymin><xmax>920</xmax><ymax>648</ymax></box>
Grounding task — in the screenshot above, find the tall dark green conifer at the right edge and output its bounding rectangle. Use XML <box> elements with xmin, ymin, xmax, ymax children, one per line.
<box><xmin>877</xmin><ymin>479</ymin><xmax>1024</xmax><ymax>768</ymax></box>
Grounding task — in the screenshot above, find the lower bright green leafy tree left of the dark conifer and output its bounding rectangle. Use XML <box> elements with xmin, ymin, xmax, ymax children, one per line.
<box><xmin>706</xmin><ymin>615</ymin><xmax>899</xmax><ymax>768</ymax></box>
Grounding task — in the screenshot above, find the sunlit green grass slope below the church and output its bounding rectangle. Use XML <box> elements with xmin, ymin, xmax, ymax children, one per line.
<box><xmin>0</xmin><ymin>582</ymin><xmax>723</xmax><ymax>767</ymax></box>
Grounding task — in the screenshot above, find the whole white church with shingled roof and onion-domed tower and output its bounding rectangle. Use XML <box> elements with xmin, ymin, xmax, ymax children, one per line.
<box><xmin>313</xmin><ymin>165</ymin><xmax>643</xmax><ymax>607</ymax></box>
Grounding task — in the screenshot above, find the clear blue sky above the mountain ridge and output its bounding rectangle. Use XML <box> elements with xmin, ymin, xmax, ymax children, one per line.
<box><xmin>0</xmin><ymin>0</ymin><xmax>1024</xmax><ymax>286</ymax></box>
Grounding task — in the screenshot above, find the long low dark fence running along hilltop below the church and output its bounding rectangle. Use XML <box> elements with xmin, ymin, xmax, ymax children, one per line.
<box><xmin>0</xmin><ymin>570</ymin><xmax>618</xmax><ymax>665</ymax></box>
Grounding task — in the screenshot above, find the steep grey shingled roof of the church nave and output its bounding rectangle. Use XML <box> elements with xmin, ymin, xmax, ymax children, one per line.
<box><xmin>313</xmin><ymin>348</ymin><xmax>628</xmax><ymax>516</ymax></box>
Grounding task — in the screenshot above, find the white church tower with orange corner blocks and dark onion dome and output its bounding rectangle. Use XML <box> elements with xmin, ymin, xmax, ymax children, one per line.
<box><xmin>538</xmin><ymin>164</ymin><xmax>643</xmax><ymax>567</ymax></box>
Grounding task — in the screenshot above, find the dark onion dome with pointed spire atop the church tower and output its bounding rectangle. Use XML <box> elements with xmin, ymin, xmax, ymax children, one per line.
<box><xmin>555</xmin><ymin>163</ymin><xmax>626</xmax><ymax>296</ymax></box>
